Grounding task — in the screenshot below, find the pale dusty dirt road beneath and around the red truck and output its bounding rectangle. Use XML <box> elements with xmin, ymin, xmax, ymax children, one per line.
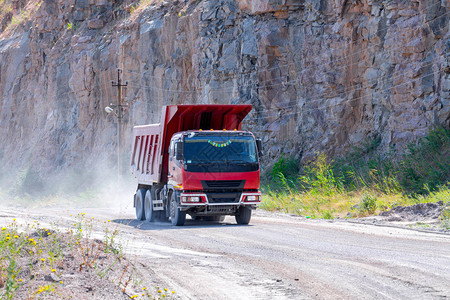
<box><xmin>0</xmin><ymin>206</ymin><xmax>450</xmax><ymax>299</ymax></box>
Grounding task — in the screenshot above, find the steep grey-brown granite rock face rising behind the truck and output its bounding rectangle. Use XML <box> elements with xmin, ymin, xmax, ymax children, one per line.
<box><xmin>0</xmin><ymin>0</ymin><xmax>450</xmax><ymax>177</ymax></box>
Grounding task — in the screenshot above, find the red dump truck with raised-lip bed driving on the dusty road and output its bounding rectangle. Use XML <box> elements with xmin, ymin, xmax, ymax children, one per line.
<box><xmin>131</xmin><ymin>104</ymin><xmax>262</xmax><ymax>226</ymax></box>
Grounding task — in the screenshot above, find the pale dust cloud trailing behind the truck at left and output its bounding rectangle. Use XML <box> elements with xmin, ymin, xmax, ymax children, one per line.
<box><xmin>0</xmin><ymin>162</ymin><xmax>137</xmax><ymax>213</ymax></box>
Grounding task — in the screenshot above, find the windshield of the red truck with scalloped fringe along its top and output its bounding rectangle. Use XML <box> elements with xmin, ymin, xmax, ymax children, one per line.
<box><xmin>184</xmin><ymin>134</ymin><xmax>258</xmax><ymax>164</ymax></box>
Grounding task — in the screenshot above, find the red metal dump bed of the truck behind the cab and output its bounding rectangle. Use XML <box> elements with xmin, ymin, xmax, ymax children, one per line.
<box><xmin>131</xmin><ymin>104</ymin><xmax>252</xmax><ymax>185</ymax></box>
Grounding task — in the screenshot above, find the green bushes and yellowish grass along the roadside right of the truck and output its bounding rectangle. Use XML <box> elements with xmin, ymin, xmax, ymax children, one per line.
<box><xmin>260</xmin><ymin>128</ymin><xmax>450</xmax><ymax>220</ymax></box>
